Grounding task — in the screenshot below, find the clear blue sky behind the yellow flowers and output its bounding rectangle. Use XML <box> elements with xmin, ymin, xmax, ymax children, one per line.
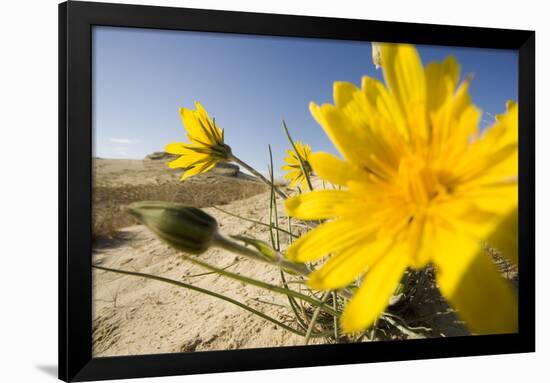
<box><xmin>92</xmin><ymin>26</ymin><xmax>517</xmax><ymax>176</ymax></box>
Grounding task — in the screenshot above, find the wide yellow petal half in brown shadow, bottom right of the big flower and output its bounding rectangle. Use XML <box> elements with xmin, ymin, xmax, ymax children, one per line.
<box><xmin>434</xmin><ymin>230</ymin><xmax>518</xmax><ymax>334</ymax></box>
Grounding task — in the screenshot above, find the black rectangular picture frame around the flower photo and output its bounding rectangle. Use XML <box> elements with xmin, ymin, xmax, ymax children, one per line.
<box><xmin>59</xmin><ymin>1</ymin><xmax>535</xmax><ymax>381</ymax></box>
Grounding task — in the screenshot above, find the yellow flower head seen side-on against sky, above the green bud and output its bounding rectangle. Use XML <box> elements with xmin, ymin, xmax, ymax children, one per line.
<box><xmin>166</xmin><ymin>102</ymin><xmax>231</xmax><ymax>180</ymax></box>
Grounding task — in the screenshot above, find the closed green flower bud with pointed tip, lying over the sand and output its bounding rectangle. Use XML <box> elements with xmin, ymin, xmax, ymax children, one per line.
<box><xmin>128</xmin><ymin>202</ymin><xmax>218</xmax><ymax>254</ymax></box>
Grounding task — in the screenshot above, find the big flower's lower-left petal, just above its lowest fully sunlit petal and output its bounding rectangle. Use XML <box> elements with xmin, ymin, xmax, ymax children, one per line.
<box><xmin>307</xmin><ymin>234</ymin><xmax>392</xmax><ymax>290</ymax></box>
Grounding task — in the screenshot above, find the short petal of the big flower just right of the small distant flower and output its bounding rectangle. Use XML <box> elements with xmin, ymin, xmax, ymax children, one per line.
<box><xmin>309</xmin><ymin>152</ymin><xmax>366</xmax><ymax>186</ymax></box>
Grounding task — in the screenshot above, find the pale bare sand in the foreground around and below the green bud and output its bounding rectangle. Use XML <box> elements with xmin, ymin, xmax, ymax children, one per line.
<box><xmin>93</xmin><ymin>195</ymin><xmax>320</xmax><ymax>356</ymax></box>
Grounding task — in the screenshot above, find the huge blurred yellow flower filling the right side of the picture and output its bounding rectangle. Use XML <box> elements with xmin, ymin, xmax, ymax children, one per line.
<box><xmin>285</xmin><ymin>44</ymin><xmax>518</xmax><ymax>334</ymax></box>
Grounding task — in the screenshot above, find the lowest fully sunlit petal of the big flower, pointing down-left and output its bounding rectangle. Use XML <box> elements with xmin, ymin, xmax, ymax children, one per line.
<box><xmin>341</xmin><ymin>250</ymin><xmax>407</xmax><ymax>333</ymax></box>
